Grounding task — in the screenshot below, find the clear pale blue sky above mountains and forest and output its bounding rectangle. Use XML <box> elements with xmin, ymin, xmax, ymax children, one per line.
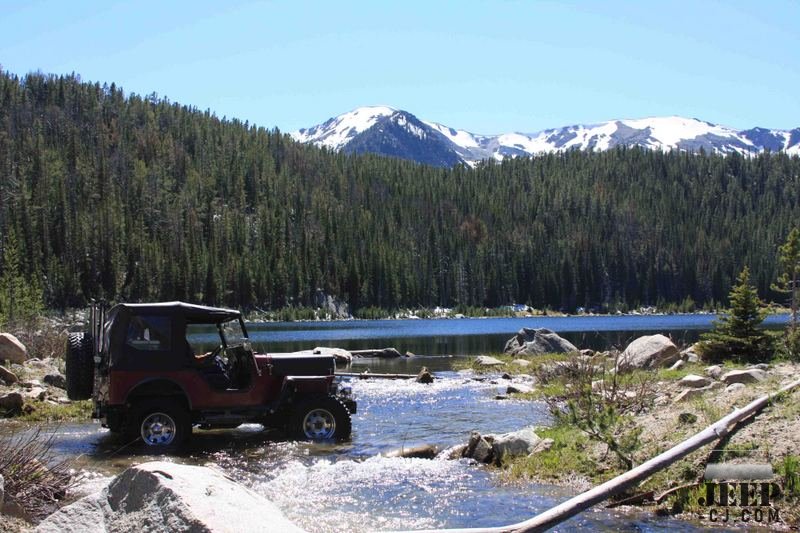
<box><xmin>0</xmin><ymin>0</ymin><xmax>800</xmax><ymax>134</ymax></box>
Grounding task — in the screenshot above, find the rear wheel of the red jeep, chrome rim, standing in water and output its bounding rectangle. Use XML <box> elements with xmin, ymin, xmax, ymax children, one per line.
<box><xmin>134</xmin><ymin>400</ymin><xmax>192</xmax><ymax>450</ymax></box>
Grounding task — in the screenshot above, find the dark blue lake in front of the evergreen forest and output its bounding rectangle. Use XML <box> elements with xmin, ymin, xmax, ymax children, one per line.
<box><xmin>247</xmin><ymin>314</ymin><xmax>788</xmax><ymax>355</ymax></box>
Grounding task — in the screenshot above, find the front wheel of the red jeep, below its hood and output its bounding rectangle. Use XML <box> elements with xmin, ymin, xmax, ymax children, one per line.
<box><xmin>292</xmin><ymin>396</ymin><xmax>352</xmax><ymax>440</ymax></box>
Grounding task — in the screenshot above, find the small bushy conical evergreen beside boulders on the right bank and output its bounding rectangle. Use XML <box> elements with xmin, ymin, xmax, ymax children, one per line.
<box><xmin>699</xmin><ymin>267</ymin><xmax>772</xmax><ymax>363</ymax></box>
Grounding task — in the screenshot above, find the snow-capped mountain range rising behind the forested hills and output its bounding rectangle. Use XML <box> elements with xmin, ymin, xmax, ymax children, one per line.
<box><xmin>292</xmin><ymin>106</ymin><xmax>800</xmax><ymax>166</ymax></box>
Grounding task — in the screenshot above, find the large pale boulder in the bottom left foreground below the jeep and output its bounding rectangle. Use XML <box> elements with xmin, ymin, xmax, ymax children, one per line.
<box><xmin>36</xmin><ymin>461</ymin><xmax>303</xmax><ymax>533</ymax></box>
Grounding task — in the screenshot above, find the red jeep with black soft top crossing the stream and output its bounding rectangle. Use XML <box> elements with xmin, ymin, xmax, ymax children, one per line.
<box><xmin>66</xmin><ymin>302</ymin><xmax>356</xmax><ymax>448</ymax></box>
